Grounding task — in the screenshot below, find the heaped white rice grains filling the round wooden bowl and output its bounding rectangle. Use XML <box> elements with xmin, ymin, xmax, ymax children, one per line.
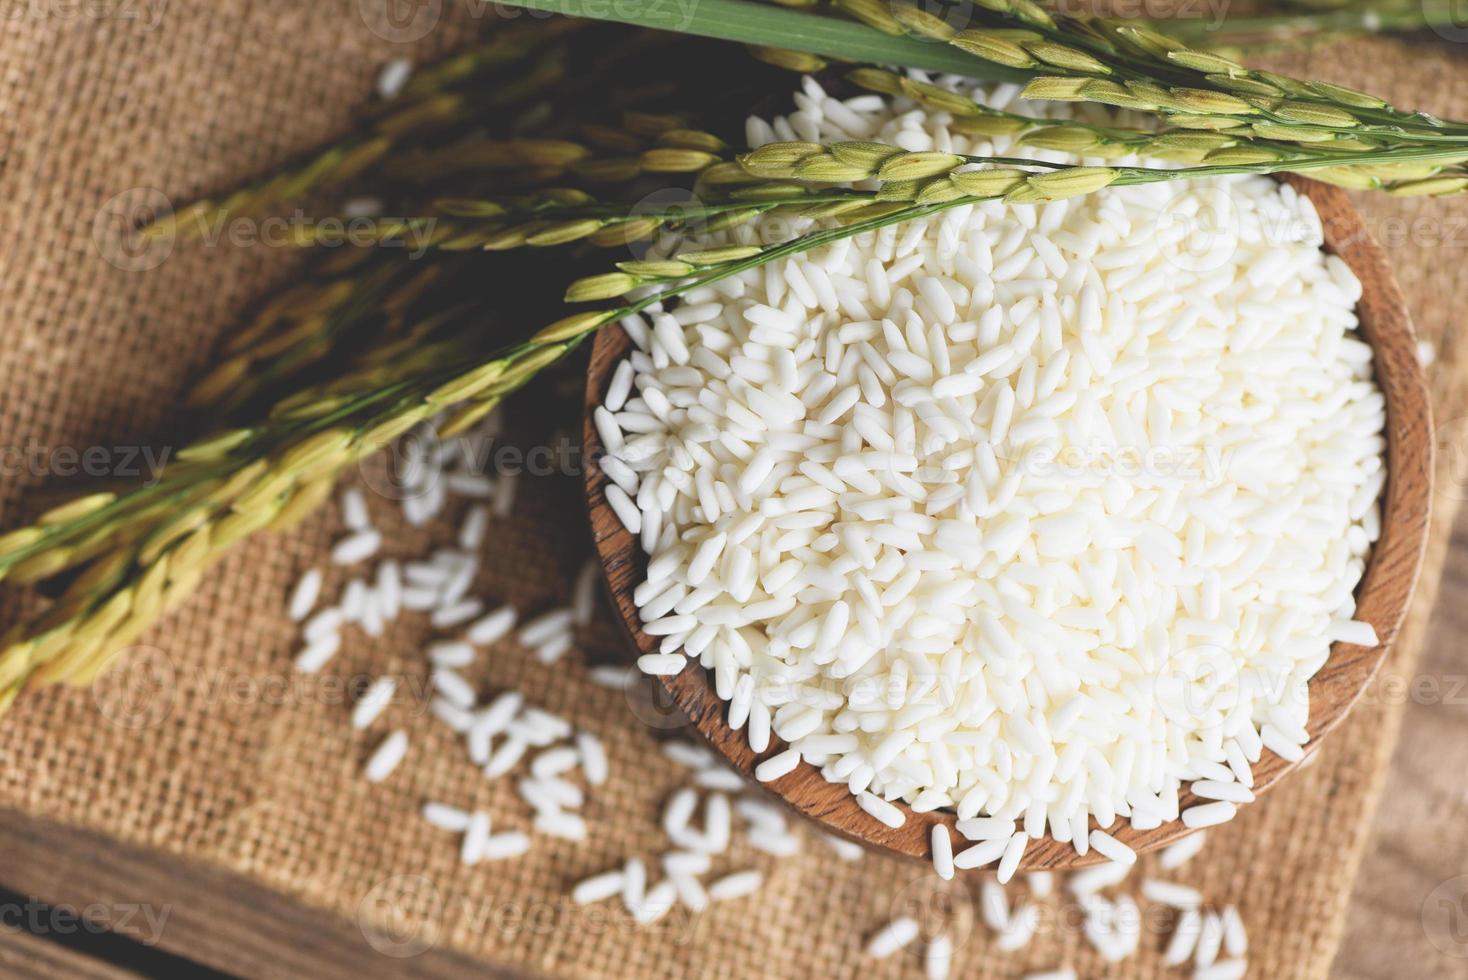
<box><xmin>596</xmin><ymin>72</ymin><xmax>1386</xmax><ymax>862</ymax></box>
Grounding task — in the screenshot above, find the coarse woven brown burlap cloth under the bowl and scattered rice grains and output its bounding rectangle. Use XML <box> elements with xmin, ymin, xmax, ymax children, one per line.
<box><xmin>0</xmin><ymin>0</ymin><xmax>1468</xmax><ymax>977</ymax></box>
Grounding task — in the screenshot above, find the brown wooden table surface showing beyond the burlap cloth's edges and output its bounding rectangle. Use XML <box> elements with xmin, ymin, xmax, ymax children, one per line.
<box><xmin>0</xmin><ymin>509</ymin><xmax>1468</xmax><ymax>980</ymax></box>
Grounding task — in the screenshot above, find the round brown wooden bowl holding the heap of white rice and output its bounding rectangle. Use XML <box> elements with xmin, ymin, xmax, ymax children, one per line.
<box><xmin>586</xmin><ymin>176</ymin><xmax>1433</xmax><ymax>871</ymax></box>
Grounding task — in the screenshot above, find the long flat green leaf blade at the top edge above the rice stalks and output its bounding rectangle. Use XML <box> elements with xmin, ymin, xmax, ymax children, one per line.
<box><xmin>504</xmin><ymin>0</ymin><xmax>1029</xmax><ymax>81</ymax></box>
